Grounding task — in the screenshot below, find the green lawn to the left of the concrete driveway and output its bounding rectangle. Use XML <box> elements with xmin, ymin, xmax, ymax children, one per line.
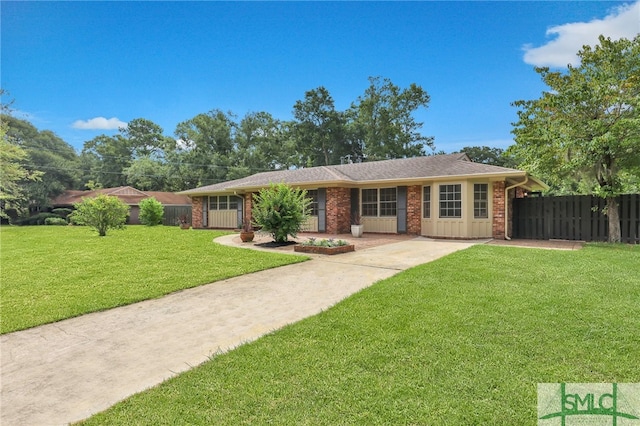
<box><xmin>0</xmin><ymin>226</ymin><xmax>305</xmax><ymax>333</ymax></box>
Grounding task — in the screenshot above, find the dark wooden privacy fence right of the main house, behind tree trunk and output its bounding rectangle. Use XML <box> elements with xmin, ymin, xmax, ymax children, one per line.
<box><xmin>513</xmin><ymin>194</ymin><xmax>640</xmax><ymax>244</ymax></box>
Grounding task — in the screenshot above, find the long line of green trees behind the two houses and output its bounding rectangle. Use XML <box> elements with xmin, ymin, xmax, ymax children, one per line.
<box><xmin>3</xmin><ymin>77</ymin><xmax>433</xmax><ymax>215</ymax></box>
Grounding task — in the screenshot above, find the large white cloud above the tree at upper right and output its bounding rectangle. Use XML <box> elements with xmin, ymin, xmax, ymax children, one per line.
<box><xmin>524</xmin><ymin>0</ymin><xmax>640</xmax><ymax>67</ymax></box>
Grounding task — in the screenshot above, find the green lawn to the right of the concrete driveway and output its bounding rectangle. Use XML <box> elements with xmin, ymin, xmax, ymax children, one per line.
<box><xmin>77</xmin><ymin>245</ymin><xmax>640</xmax><ymax>425</ymax></box>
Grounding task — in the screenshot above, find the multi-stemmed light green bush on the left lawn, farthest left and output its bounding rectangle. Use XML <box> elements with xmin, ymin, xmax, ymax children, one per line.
<box><xmin>71</xmin><ymin>194</ymin><xmax>129</xmax><ymax>237</ymax></box>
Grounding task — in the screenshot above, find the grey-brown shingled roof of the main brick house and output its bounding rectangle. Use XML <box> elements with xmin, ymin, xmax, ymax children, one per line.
<box><xmin>180</xmin><ymin>154</ymin><xmax>544</xmax><ymax>195</ymax></box>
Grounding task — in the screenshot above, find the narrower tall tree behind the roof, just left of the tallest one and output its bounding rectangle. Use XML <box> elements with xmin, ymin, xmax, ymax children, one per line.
<box><xmin>293</xmin><ymin>86</ymin><xmax>350</xmax><ymax>166</ymax></box>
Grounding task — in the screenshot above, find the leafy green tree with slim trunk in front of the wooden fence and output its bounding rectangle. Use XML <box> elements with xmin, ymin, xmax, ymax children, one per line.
<box><xmin>510</xmin><ymin>36</ymin><xmax>640</xmax><ymax>242</ymax></box>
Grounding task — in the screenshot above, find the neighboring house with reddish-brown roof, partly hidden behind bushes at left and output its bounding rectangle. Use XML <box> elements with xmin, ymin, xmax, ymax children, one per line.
<box><xmin>51</xmin><ymin>186</ymin><xmax>191</xmax><ymax>225</ymax></box>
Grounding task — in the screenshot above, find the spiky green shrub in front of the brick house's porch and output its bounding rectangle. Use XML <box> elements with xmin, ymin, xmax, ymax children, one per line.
<box><xmin>252</xmin><ymin>183</ymin><xmax>311</xmax><ymax>243</ymax></box>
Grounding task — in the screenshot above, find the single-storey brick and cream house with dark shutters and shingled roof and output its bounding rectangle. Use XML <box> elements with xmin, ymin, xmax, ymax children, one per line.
<box><xmin>180</xmin><ymin>154</ymin><xmax>547</xmax><ymax>239</ymax></box>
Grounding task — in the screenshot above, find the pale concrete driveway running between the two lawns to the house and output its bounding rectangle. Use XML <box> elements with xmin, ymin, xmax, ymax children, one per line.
<box><xmin>0</xmin><ymin>235</ymin><xmax>484</xmax><ymax>426</ymax></box>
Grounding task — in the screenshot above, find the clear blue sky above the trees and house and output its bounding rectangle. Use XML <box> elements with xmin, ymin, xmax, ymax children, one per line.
<box><xmin>0</xmin><ymin>1</ymin><xmax>640</xmax><ymax>152</ymax></box>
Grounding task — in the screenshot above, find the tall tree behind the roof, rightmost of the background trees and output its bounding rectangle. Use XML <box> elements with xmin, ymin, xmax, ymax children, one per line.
<box><xmin>350</xmin><ymin>77</ymin><xmax>434</xmax><ymax>160</ymax></box>
